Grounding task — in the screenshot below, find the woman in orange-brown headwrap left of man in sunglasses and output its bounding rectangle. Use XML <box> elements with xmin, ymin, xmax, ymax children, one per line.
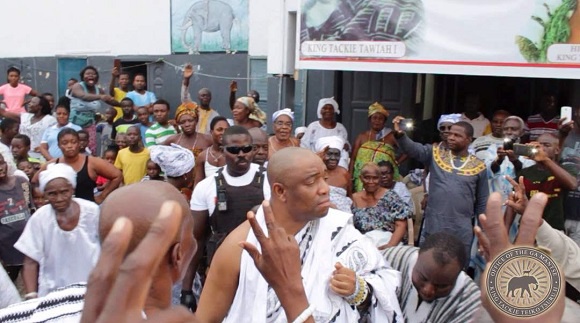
<box><xmin>163</xmin><ymin>102</ymin><xmax>212</xmax><ymax>158</ymax></box>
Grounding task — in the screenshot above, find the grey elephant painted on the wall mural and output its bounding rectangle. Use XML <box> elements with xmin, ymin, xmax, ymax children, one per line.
<box><xmin>181</xmin><ymin>0</ymin><xmax>235</xmax><ymax>54</ymax></box>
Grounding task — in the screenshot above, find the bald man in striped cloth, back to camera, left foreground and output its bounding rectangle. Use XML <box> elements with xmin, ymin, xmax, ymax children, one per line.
<box><xmin>0</xmin><ymin>181</ymin><xmax>197</xmax><ymax>322</ymax></box>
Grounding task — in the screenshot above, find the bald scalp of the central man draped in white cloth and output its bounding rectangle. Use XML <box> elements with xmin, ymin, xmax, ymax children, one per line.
<box><xmin>268</xmin><ymin>147</ymin><xmax>324</xmax><ymax>186</ymax></box>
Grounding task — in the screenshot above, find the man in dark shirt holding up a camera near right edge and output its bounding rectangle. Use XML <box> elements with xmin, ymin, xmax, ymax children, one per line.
<box><xmin>518</xmin><ymin>133</ymin><xmax>578</xmax><ymax>231</ymax></box>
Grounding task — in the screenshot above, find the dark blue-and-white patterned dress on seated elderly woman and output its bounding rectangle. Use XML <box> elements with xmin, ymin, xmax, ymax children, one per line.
<box><xmin>352</xmin><ymin>190</ymin><xmax>411</xmax><ymax>234</ymax></box>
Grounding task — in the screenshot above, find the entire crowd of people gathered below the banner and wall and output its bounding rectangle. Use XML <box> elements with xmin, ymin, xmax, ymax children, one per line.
<box><xmin>0</xmin><ymin>65</ymin><xmax>580</xmax><ymax>322</ymax></box>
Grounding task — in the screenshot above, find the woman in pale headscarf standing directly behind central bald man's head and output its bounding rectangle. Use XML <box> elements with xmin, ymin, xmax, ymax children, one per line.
<box><xmin>268</xmin><ymin>109</ymin><xmax>300</xmax><ymax>159</ymax></box>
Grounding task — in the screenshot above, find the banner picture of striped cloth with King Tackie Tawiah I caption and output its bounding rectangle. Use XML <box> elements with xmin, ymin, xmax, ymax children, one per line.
<box><xmin>300</xmin><ymin>0</ymin><xmax>424</xmax><ymax>58</ymax></box>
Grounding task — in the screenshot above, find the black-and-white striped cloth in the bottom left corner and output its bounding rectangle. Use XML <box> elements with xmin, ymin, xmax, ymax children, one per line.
<box><xmin>0</xmin><ymin>283</ymin><xmax>87</xmax><ymax>323</ymax></box>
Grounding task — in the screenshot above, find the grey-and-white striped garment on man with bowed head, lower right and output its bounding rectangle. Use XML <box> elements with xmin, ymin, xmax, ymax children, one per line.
<box><xmin>381</xmin><ymin>246</ymin><xmax>481</xmax><ymax>323</ymax></box>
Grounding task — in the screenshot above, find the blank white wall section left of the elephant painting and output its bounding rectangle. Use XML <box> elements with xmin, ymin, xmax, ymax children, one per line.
<box><xmin>0</xmin><ymin>0</ymin><xmax>171</xmax><ymax>57</ymax></box>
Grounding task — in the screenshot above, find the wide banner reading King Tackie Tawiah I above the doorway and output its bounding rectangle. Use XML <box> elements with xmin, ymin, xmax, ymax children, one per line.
<box><xmin>297</xmin><ymin>0</ymin><xmax>580</xmax><ymax>78</ymax></box>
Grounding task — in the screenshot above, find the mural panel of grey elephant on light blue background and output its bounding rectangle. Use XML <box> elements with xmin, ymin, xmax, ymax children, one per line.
<box><xmin>171</xmin><ymin>0</ymin><xmax>249</xmax><ymax>54</ymax></box>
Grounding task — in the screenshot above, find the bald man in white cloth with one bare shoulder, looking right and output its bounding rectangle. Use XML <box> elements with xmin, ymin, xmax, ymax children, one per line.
<box><xmin>196</xmin><ymin>147</ymin><xmax>403</xmax><ymax>323</ymax></box>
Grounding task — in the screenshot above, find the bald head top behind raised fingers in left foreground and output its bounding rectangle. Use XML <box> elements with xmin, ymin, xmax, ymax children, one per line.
<box><xmin>99</xmin><ymin>181</ymin><xmax>193</xmax><ymax>253</ymax></box>
